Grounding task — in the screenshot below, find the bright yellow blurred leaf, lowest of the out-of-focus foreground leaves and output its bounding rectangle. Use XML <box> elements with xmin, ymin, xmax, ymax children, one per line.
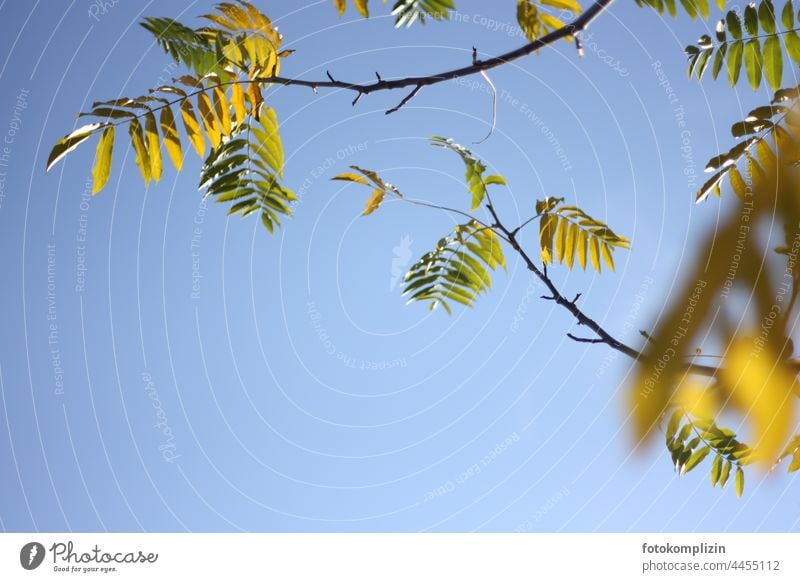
<box><xmin>721</xmin><ymin>337</ymin><xmax>795</xmax><ymax>466</ymax></box>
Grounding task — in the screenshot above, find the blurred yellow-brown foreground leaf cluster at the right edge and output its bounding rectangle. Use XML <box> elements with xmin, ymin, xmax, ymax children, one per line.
<box><xmin>629</xmin><ymin>122</ymin><xmax>800</xmax><ymax>492</ymax></box>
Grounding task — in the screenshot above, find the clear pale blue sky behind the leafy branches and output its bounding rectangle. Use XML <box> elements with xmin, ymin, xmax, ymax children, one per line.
<box><xmin>0</xmin><ymin>0</ymin><xmax>800</xmax><ymax>532</ymax></box>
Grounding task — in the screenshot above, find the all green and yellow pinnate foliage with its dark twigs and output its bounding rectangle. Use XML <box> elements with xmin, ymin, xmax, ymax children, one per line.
<box><xmin>47</xmin><ymin>0</ymin><xmax>800</xmax><ymax>496</ymax></box>
